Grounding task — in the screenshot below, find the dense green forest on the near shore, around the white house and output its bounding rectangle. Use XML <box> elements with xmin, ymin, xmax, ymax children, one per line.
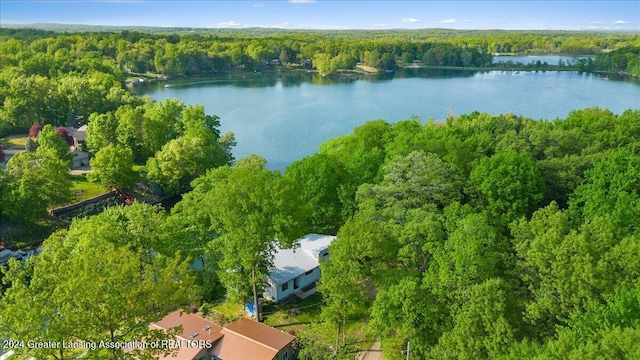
<box><xmin>0</xmin><ymin>104</ymin><xmax>640</xmax><ymax>359</ymax></box>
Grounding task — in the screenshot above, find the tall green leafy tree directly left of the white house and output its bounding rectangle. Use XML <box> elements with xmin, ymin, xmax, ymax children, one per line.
<box><xmin>196</xmin><ymin>155</ymin><xmax>302</xmax><ymax>320</ymax></box>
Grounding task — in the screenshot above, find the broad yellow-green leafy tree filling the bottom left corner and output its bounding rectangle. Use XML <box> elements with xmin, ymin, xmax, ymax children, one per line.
<box><xmin>0</xmin><ymin>216</ymin><xmax>197</xmax><ymax>359</ymax></box>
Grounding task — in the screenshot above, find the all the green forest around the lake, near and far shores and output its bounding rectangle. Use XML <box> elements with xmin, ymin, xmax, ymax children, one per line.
<box><xmin>0</xmin><ymin>29</ymin><xmax>640</xmax><ymax>360</ymax></box>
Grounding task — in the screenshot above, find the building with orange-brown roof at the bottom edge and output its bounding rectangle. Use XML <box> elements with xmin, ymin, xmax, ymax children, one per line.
<box><xmin>151</xmin><ymin>311</ymin><xmax>295</xmax><ymax>360</ymax></box>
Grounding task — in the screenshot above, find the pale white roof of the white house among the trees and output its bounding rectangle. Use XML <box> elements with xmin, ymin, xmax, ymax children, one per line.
<box><xmin>269</xmin><ymin>234</ymin><xmax>336</xmax><ymax>285</ymax></box>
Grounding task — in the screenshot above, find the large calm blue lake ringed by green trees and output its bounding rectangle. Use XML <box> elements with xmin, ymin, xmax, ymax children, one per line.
<box><xmin>132</xmin><ymin>69</ymin><xmax>640</xmax><ymax>170</ymax></box>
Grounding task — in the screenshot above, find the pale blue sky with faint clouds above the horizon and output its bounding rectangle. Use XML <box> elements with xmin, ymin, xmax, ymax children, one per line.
<box><xmin>0</xmin><ymin>0</ymin><xmax>640</xmax><ymax>31</ymax></box>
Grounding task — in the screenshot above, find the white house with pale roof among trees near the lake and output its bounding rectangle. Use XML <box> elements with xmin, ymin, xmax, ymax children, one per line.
<box><xmin>263</xmin><ymin>234</ymin><xmax>336</xmax><ymax>302</ymax></box>
